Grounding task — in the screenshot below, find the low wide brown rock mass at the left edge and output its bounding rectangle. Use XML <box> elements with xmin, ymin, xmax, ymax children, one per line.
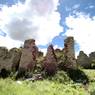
<box><xmin>0</xmin><ymin>47</ymin><xmax>21</xmax><ymax>76</ymax></box>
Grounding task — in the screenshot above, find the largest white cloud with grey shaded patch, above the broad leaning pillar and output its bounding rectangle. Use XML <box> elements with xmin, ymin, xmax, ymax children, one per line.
<box><xmin>0</xmin><ymin>0</ymin><xmax>63</xmax><ymax>46</ymax></box>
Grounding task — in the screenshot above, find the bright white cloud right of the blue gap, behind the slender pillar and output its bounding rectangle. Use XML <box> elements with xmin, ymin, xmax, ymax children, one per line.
<box><xmin>66</xmin><ymin>13</ymin><xmax>95</xmax><ymax>54</ymax></box>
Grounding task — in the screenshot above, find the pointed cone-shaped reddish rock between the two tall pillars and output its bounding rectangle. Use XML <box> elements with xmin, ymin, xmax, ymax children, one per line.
<box><xmin>43</xmin><ymin>45</ymin><xmax>57</xmax><ymax>75</ymax></box>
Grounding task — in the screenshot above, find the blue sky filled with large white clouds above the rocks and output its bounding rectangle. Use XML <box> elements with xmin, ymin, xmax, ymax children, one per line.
<box><xmin>0</xmin><ymin>0</ymin><xmax>95</xmax><ymax>54</ymax></box>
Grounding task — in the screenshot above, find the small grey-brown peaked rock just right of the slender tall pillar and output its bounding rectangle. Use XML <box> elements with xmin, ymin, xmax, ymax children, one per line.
<box><xmin>77</xmin><ymin>51</ymin><xmax>91</xmax><ymax>68</ymax></box>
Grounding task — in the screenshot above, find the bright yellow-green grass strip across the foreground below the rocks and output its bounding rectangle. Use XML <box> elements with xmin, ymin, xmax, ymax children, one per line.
<box><xmin>0</xmin><ymin>79</ymin><xmax>89</xmax><ymax>95</ymax></box>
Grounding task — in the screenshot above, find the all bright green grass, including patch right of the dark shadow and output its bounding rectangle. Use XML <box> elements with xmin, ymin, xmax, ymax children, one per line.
<box><xmin>0</xmin><ymin>70</ymin><xmax>95</xmax><ymax>95</ymax></box>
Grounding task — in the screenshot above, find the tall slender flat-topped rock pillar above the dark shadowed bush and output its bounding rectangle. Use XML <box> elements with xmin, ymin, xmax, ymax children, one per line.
<box><xmin>64</xmin><ymin>37</ymin><xmax>77</xmax><ymax>69</ymax></box>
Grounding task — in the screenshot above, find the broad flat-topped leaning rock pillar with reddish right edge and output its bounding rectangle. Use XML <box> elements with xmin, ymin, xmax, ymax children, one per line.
<box><xmin>19</xmin><ymin>39</ymin><xmax>38</xmax><ymax>76</ymax></box>
